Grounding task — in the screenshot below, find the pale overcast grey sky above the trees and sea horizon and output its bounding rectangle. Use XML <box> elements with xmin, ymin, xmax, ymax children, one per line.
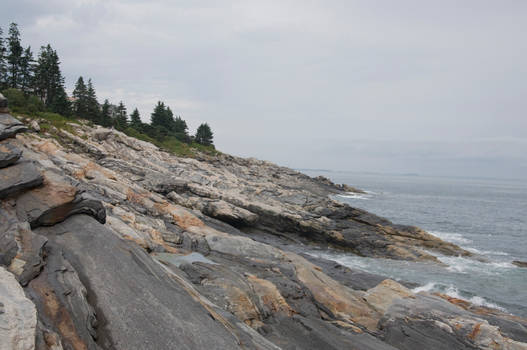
<box><xmin>0</xmin><ymin>0</ymin><xmax>527</xmax><ymax>180</ymax></box>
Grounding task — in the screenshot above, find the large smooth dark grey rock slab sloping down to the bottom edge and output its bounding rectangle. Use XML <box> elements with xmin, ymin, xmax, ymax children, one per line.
<box><xmin>36</xmin><ymin>215</ymin><xmax>254</xmax><ymax>350</ymax></box>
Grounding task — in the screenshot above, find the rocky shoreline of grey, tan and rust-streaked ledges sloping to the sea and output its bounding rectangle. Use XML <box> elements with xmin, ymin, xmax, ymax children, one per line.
<box><xmin>0</xmin><ymin>93</ymin><xmax>527</xmax><ymax>350</ymax></box>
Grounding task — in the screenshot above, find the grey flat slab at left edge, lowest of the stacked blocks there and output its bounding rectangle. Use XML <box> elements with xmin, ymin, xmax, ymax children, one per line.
<box><xmin>0</xmin><ymin>161</ymin><xmax>43</xmax><ymax>198</ymax></box>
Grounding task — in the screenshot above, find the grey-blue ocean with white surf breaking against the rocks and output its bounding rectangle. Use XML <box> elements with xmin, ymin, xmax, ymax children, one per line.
<box><xmin>303</xmin><ymin>170</ymin><xmax>527</xmax><ymax>317</ymax></box>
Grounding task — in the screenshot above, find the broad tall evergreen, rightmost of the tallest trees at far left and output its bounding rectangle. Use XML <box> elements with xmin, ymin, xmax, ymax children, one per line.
<box><xmin>34</xmin><ymin>44</ymin><xmax>71</xmax><ymax>115</ymax></box>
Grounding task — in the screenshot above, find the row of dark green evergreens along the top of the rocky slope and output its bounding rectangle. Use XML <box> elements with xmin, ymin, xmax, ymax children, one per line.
<box><xmin>0</xmin><ymin>23</ymin><xmax>213</xmax><ymax>146</ymax></box>
